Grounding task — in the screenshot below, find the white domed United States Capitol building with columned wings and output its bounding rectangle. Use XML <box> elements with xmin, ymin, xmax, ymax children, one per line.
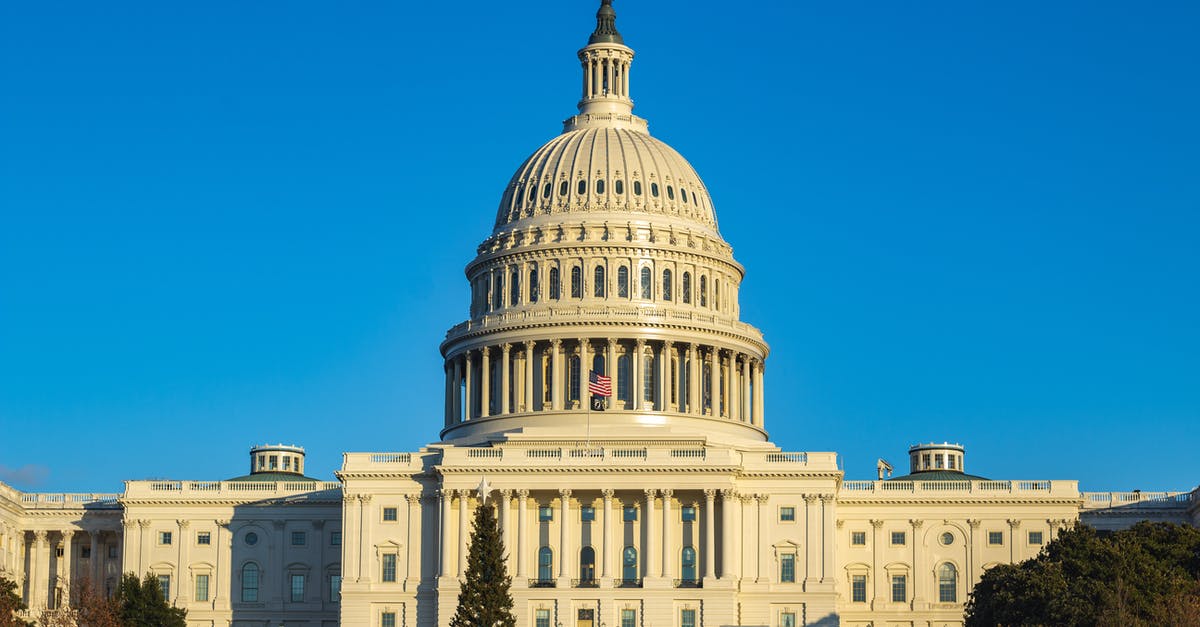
<box><xmin>0</xmin><ymin>0</ymin><xmax>1200</xmax><ymax>627</ymax></box>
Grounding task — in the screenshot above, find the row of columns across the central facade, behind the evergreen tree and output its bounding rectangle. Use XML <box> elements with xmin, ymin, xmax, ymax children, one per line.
<box><xmin>438</xmin><ymin>488</ymin><xmax>820</xmax><ymax>586</ymax></box>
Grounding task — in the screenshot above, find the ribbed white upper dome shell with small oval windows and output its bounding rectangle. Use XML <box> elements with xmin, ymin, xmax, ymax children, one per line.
<box><xmin>496</xmin><ymin>125</ymin><xmax>716</xmax><ymax>235</ymax></box>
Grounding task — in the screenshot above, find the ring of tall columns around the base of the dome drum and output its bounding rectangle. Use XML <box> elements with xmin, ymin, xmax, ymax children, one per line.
<box><xmin>445</xmin><ymin>338</ymin><xmax>763</xmax><ymax>428</ymax></box>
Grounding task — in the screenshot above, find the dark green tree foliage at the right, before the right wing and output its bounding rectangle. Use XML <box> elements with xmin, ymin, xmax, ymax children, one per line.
<box><xmin>966</xmin><ymin>523</ymin><xmax>1200</xmax><ymax>627</ymax></box>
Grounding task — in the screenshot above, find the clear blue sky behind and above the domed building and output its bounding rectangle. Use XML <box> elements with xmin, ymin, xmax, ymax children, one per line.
<box><xmin>0</xmin><ymin>0</ymin><xmax>1200</xmax><ymax>491</ymax></box>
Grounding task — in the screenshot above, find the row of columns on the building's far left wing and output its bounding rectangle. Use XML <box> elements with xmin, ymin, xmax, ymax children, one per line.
<box><xmin>7</xmin><ymin>527</ymin><xmax>120</xmax><ymax>608</ymax></box>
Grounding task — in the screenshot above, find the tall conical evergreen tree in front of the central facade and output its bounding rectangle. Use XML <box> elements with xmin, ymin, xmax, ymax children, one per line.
<box><xmin>450</xmin><ymin>492</ymin><xmax>516</xmax><ymax>627</ymax></box>
